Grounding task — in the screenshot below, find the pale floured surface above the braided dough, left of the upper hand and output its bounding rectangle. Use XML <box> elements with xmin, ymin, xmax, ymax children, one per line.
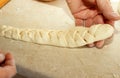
<box><xmin>0</xmin><ymin>0</ymin><xmax>75</xmax><ymax>29</ymax></box>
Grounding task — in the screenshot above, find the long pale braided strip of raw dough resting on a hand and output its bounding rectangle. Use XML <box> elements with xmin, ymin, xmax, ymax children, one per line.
<box><xmin>0</xmin><ymin>24</ymin><xmax>114</xmax><ymax>48</ymax></box>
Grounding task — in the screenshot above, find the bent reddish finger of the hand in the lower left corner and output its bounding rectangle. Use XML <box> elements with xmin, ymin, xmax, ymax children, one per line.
<box><xmin>5</xmin><ymin>53</ymin><xmax>15</xmax><ymax>66</ymax></box>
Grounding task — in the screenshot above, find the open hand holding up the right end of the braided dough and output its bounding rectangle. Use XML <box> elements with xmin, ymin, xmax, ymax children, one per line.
<box><xmin>67</xmin><ymin>0</ymin><xmax>120</xmax><ymax>48</ymax></box>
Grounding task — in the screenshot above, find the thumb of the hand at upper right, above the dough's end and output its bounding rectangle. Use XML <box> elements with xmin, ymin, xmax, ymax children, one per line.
<box><xmin>96</xmin><ymin>0</ymin><xmax>120</xmax><ymax>20</ymax></box>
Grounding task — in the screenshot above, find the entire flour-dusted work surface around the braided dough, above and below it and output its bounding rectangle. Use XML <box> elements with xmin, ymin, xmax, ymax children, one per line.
<box><xmin>0</xmin><ymin>0</ymin><xmax>120</xmax><ymax>78</ymax></box>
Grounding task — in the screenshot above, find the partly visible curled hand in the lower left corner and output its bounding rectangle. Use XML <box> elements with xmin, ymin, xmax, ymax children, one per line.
<box><xmin>0</xmin><ymin>51</ymin><xmax>16</xmax><ymax>78</ymax></box>
